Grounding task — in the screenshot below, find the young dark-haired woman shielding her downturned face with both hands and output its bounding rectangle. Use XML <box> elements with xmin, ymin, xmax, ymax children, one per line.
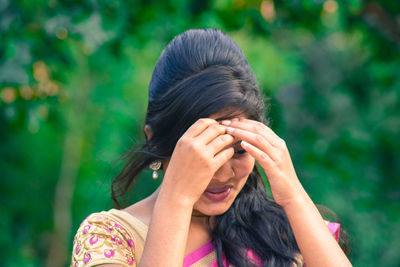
<box><xmin>71</xmin><ymin>30</ymin><xmax>351</xmax><ymax>267</ymax></box>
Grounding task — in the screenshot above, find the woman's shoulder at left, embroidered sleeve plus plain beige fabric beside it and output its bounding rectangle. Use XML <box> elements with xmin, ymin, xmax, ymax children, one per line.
<box><xmin>71</xmin><ymin>209</ymin><xmax>147</xmax><ymax>266</ymax></box>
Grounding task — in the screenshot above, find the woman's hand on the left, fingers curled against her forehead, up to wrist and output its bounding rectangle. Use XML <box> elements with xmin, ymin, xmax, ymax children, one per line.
<box><xmin>161</xmin><ymin>118</ymin><xmax>234</xmax><ymax>206</ymax></box>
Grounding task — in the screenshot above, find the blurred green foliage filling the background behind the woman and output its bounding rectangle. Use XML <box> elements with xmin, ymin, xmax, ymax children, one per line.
<box><xmin>0</xmin><ymin>0</ymin><xmax>400</xmax><ymax>266</ymax></box>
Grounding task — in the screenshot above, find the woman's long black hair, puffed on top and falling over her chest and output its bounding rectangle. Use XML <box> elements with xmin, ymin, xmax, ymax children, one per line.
<box><xmin>112</xmin><ymin>29</ymin><xmax>346</xmax><ymax>267</ymax></box>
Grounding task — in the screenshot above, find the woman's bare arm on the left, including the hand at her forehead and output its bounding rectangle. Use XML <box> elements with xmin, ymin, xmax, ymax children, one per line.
<box><xmin>138</xmin><ymin>119</ymin><xmax>234</xmax><ymax>267</ymax></box>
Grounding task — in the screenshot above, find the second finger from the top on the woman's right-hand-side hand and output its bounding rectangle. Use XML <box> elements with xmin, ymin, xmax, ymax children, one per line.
<box><xmin>226</xmin><ymin>127</ymin><xmax>277</xmax><ymax>160</ymax></box>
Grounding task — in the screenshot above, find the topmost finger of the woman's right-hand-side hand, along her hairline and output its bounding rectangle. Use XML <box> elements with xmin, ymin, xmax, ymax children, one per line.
<box><xmin>221</xmin><ymin>119</ymin><xmax>280</xmax><ymax>147</ymax></box>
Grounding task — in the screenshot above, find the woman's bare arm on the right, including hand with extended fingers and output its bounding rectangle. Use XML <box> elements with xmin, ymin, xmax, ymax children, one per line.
<box><xmin>223</xmin><ymin>119</ymin><xmax>351</xmax><ymax>267</ymax></box>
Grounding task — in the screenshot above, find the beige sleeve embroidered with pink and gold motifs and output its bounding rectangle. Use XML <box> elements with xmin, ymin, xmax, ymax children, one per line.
<box><xmin>71</xmin><ymin>213</ymin><xmax>136</xmax><ymax>267</ymax></box>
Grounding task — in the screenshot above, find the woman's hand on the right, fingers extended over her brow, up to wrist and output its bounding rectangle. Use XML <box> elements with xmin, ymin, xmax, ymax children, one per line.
<box><xmin>222</xmin><ymin>119</ymin><xmax>305</xmax><ymax>207</ymax></box>
